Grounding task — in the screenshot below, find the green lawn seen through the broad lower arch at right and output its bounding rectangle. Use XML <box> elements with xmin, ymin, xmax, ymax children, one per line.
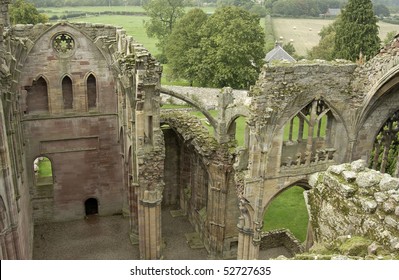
<box><xmin>263</xmin><ymin>186</ymin><xmax>309</xmax><ymax>242</ymax></box>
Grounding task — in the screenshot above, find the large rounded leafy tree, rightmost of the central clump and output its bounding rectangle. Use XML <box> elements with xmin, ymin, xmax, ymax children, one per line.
<box><xmin>194</xmin><ymin>7</ymin><xmax>265</xmax><ymax>88</ymax></box>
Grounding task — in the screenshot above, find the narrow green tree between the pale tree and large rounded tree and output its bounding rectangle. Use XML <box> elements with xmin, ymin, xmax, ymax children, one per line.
<box><xmin>165</xmin><ymin>9</ymin><xmax>207</xmax><ymax>84</ymax></box>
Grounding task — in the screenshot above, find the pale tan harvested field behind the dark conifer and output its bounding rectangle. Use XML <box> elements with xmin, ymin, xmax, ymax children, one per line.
<box><xmin>273</xmin><ymin>18</ymin><xmax>399</xmax><ymax>56</ymax></box>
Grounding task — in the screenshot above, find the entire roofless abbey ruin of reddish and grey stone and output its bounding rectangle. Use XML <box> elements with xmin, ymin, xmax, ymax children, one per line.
<box><xmin>0</xmin><ymin>0</ymin><xmax>399</xmax><ymax>259</ymax></box>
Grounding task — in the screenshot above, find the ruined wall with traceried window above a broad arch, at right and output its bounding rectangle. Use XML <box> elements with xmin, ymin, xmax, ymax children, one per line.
<box><xmin>238</xmin><ymin>38</ymin><xmax>399</xmax><ymax>259</ymax></box>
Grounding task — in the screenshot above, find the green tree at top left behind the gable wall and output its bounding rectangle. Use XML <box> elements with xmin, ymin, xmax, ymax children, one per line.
<box><xmin>10</xmin><ymin>0</ymin><xmax>48</xmax><ymax>24</ymax></box>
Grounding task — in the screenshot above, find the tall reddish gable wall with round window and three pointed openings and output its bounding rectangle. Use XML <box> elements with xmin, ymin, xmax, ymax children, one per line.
<box><xmin>11</xmin><ymin>24</ymin><xmax>122</xmax><ymax>222</ymax></box>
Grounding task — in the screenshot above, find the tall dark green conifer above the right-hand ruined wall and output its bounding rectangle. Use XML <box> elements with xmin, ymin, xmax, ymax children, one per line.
<box><xmin>334</xmin><ymin>0</ymin><xmax>380</xmax><ymax>61</ymax></box>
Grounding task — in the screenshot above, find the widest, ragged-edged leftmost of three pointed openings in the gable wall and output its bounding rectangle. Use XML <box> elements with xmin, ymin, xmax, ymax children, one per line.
<box><xmin>25</xmin><ymin>77</ymin><xmax>49</xmax><ymax>114</ymax></box>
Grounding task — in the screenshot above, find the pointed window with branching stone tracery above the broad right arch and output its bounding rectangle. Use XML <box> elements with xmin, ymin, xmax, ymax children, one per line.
<box><xmin>281</xmin><ymin>99</ymin><xmax>336</xmax><ymax>167</ymax></box>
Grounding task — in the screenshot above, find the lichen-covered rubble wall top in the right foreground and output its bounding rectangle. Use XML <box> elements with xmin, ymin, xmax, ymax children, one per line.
<box><xmin>306</xmin><ymin>160</ymin><xmax>399</xmax><ymax>255</ymax></box>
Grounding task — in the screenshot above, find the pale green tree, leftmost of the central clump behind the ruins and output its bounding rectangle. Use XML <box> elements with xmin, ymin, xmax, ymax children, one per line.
<box><xmin>143</xmin><ymin>0</ymin><xmax>184</xmax><ymax>57</ymax></box>
